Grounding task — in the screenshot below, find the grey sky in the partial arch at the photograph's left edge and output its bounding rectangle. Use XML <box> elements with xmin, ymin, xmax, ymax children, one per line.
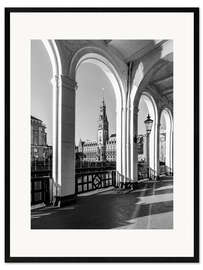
<box><xmin>31</xmin><ymin>40</ymin><xmax>53</xmax><ymax>145</ymax></box>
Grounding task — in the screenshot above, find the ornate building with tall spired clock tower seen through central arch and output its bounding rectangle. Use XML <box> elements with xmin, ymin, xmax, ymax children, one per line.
<box><xmin>76</xmin><ymin>99</ymin><xmax>116</xmax><ymax>162</ymax></box>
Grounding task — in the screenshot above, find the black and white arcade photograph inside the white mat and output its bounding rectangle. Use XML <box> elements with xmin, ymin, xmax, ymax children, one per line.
<box><xmin>31</xmin><ymin>40</ymin><xmax>175</xmax><ymax>229</ymax></box>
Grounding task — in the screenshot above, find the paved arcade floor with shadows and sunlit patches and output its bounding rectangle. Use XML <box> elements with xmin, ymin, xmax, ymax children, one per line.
<box><xmin>31</xmin><ymin>179</ymin><xmax>173</xmax><ymax>229</ymax></box>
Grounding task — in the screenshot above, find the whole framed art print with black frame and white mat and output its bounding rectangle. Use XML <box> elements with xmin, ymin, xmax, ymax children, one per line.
<box><xmin>5</xmin><ymin>8</ymin><xmax>199</xmax><ymax>262</ymax></box>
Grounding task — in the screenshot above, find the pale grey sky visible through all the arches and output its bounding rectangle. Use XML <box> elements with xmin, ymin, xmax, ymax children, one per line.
<box><xmin>31</xmin><ymin>40</ymin><xmax>155</xmax><ymax>145</ymax></box>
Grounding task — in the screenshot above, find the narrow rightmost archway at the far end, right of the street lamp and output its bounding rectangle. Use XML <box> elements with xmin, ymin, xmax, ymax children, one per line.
<box><xmin>159</xmin><ymin>108</ymin><xmax>173</xmax><ymax>175</ymax></box>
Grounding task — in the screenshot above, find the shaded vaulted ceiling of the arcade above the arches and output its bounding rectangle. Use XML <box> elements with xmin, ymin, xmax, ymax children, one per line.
<box><xmin>60</xmin><ymin>39</ymin><xmax>173</xmax><ymax>103</ymax></box>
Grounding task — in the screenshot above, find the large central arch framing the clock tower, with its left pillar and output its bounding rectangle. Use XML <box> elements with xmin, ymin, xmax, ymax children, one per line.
<box><xmin>44</xmin><ymin>41</ymin><xmax>126</xmax><ymax>205</ymax></box>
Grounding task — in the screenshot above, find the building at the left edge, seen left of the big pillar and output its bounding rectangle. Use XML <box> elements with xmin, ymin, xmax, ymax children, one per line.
<box><xmin>31</xmin><ymin>116</ymin><xmax>52</xmax><ymax>161</ymax></box>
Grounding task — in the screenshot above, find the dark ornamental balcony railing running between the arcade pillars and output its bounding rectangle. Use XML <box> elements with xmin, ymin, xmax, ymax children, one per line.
<box><xmin>31</xmin><ymin>161</ymin><xmax>173</xmax><ymax>205</ymax></box>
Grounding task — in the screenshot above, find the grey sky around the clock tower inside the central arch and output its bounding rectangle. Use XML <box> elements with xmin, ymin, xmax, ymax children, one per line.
<box><xmin>75</xmin><ymin>63</ymin><xmax>116</xmax><ymax>144</ymax></box>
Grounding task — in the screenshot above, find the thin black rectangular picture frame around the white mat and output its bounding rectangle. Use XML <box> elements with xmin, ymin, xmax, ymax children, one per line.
<box><xmin>5</xmin><ymin>7</ymin><xmax>199</xmax><ymax>263</ymax></box>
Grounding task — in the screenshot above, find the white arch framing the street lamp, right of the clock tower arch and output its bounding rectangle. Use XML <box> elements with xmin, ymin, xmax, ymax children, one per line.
<box><xmin>127</xmin><ymin>47</ymin><xmax>173</xmax><ymax>182</ymax></box>
